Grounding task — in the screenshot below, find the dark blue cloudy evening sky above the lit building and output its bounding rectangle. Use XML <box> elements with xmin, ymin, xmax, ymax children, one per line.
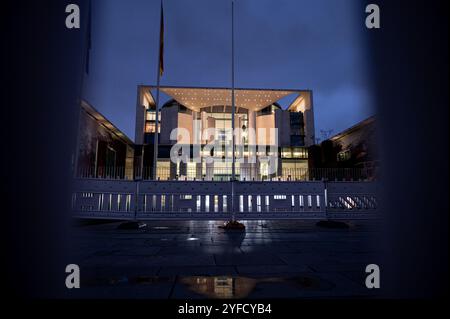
<box><xmin>82</xmin><ymin>0</ymin><xmax>374</xmax><ymax>139</ymax></box>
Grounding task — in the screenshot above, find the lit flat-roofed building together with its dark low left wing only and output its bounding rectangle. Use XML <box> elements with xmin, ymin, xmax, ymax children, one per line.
<box><xmin>76</xmin><ymin>86</ymin><xmax>315</xmax><ymax>181</ymax></box>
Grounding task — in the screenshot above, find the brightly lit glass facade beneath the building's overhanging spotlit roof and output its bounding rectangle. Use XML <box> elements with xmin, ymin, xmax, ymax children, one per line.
<box><xmin>139</xmin><ymin>95</ymin><xmax>308</xmax><ymax>181</ymax></box>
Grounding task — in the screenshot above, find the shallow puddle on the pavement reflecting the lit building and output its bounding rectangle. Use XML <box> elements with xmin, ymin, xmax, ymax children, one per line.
<box><xmin>180</xmin><ymin>275</ymin><xmax>334</xmax><ymax>299</ymax></box>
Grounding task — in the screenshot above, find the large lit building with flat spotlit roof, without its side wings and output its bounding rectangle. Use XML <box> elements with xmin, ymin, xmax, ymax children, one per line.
<box><xmin>134</xmin><ymin>86</ymin><xmax>315</xmax><ymax>181</ymax></box>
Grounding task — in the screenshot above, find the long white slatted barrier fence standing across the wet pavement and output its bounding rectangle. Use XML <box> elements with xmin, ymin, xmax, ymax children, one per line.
<box><xmin>72</xmin><ymin>179</ymin><xmax>378</xmax><ymax>220</ymax></box>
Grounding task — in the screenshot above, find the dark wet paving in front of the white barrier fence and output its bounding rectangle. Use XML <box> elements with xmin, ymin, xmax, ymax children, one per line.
<box><xmin>68</xmin><ymin>221</ymin><xmax>380</xmax><ymax>299</ymax></box>
